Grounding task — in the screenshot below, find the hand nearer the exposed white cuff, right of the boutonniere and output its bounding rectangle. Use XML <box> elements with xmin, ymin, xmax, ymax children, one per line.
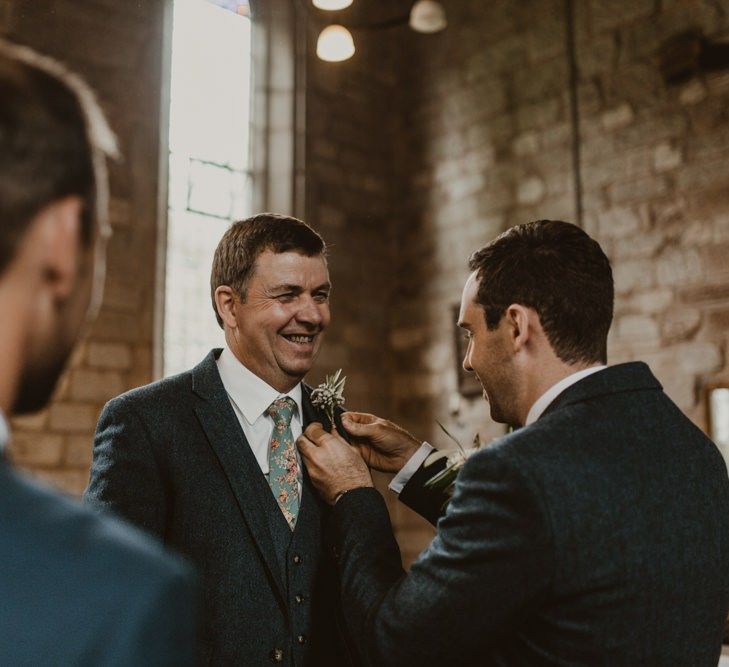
<box><xmin>342</xmin><ymin>412</ymin><xmax>423</xmax><ymax>473</ymax></box>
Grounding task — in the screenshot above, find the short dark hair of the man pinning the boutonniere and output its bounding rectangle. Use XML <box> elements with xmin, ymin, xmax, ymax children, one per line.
<box><xmin>468</xmin><ymin>220</ymin><xmax>614</xmax><ymax>363</ymax></box>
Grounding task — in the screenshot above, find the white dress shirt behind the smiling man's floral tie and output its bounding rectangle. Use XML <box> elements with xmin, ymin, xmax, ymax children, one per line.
<box><xmin>217</xmin><ymin>346</ymin><xmax>304</xmax><ymax>497</ymax></box>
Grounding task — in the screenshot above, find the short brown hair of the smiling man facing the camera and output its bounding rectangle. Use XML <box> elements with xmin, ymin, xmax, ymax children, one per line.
<box><xmin>210</xmin><ymin>213</ymin><xmax>326</xmax><ymax>328</ymax></box>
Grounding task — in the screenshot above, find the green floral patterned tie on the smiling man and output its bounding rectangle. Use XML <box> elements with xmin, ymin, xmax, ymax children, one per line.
<box><xmin>266</xmin><ymin>396</ymin><xmax>299</xmax><ymax>530</ymax></box>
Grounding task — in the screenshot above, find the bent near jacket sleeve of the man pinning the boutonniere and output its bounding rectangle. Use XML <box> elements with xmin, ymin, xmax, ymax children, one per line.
<box><xmin>334</xmin><ymin>448</ymin><xmax>553</xmax><ymax>667</ymax></box>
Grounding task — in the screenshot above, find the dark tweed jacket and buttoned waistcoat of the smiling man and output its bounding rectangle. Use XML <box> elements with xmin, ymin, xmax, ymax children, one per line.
<box><xmin>86</xmin><ymin>350</ymin><xmax>353</xmax><ymax>667</ymax></box>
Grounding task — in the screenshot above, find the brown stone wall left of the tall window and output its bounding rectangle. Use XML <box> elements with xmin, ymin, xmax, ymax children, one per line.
<box><xmin>0</xmin><ymin>0</ymin><xmax>164</xmax><ymax>493</ymax></box>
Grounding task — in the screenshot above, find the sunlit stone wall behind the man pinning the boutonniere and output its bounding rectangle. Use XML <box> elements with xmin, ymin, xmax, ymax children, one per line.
<box><xmin>392</xmin><ymin>0</ymin><xmax>729</xmax><ymax>444</ymax></box>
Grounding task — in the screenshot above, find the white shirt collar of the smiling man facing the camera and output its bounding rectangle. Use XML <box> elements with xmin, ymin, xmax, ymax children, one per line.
<box><xmin>217</xmin><ymin>346</ymin><xmax>304</xmax><ymax>424</ymax></box>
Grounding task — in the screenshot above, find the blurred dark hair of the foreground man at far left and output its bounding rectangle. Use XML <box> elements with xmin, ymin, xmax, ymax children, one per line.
<box><xmin>0</xmin><ymin>40</ymin><xmax>116</xmax><ymax>272</ymax></box>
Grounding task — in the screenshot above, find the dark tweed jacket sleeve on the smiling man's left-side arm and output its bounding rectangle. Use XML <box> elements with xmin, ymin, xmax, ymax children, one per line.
<box><xmin>84</xmin><ymin>396</ymin><xmax>166</xmax><ymax>539</ymax></box>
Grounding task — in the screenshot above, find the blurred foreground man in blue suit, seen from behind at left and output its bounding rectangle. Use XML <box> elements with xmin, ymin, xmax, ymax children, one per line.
<box><xmin>0</xmin><ymin>42</ymin><xmax>195</xmax><ymax>665</ymax></box>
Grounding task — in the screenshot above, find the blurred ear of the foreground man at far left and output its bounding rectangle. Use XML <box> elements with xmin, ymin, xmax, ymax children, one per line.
<box><xmin>33</xmin><ymin>196</ymin><xmax>83</xmax><ymax>301</ymax></box>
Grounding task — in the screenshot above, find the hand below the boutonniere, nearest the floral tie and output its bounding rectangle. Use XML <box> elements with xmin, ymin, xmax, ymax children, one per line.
<box><xmin>296</xmin><ymin>422</ymin><xmax>373</xmax><ymax>505</ymax></box>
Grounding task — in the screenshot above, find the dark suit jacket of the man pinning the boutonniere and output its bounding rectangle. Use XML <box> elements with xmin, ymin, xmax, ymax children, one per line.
<box><xmin>333</xmin><ymin>363</ymin><xmax>729</xmax><ymax>667</ymax></box>
